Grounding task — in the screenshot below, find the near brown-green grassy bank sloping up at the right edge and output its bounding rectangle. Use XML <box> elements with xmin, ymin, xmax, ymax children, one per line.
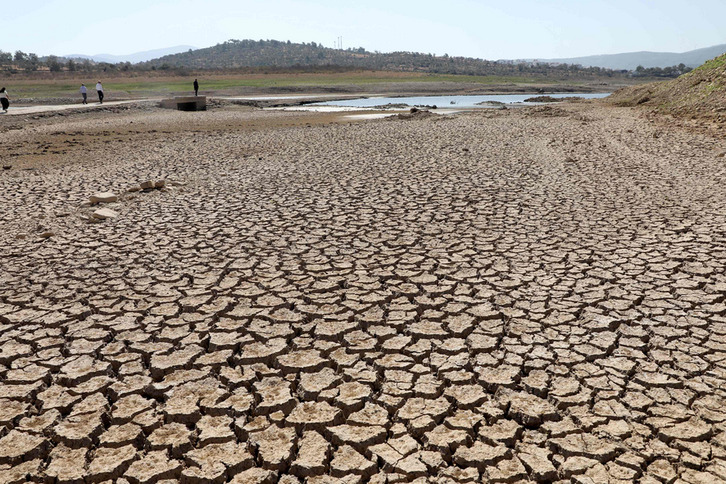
<box><xmin>608</xmin><ymin>54</ymin><xmax>726</xmax><ymax>126</ymax></box>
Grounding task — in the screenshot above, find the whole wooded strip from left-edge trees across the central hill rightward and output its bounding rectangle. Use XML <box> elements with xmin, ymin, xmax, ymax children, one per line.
<box><xmin>0</xmin><ymin>40</ymin><xmax>688</xmax><ymax>80</ymax></box>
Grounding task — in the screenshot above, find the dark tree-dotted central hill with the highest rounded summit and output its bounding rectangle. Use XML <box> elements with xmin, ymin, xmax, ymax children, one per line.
<box><xmin>139</xmin><ymin>40</ymin><xmax>623</xmax><ymax>79</ymax></box>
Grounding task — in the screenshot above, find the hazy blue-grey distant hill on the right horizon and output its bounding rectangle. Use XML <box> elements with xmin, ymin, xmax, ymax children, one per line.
<box><xmin>541</xmin><ymin>44</ymin><xmax>726</xmax><ymax>71</ymax></box>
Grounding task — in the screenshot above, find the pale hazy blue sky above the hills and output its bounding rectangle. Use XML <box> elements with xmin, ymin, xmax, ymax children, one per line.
<box><xmin>0</xmin><ymin>0</ymin><xmax>726</xmax><ymax>59</ymax></box>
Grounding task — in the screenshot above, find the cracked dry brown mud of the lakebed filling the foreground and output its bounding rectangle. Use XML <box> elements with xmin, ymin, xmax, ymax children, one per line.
<box><xmin>0</xmin><ymin>104</ymin><xmax>726</xmax><ymax>484</ymax></box>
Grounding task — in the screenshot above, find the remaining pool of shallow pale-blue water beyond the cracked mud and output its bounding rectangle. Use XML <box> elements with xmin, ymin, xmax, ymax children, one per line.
<box><xmin>311</xmin><ymin>92</ymin><xmax>610</xmax><ymax>109</ymax></box>
